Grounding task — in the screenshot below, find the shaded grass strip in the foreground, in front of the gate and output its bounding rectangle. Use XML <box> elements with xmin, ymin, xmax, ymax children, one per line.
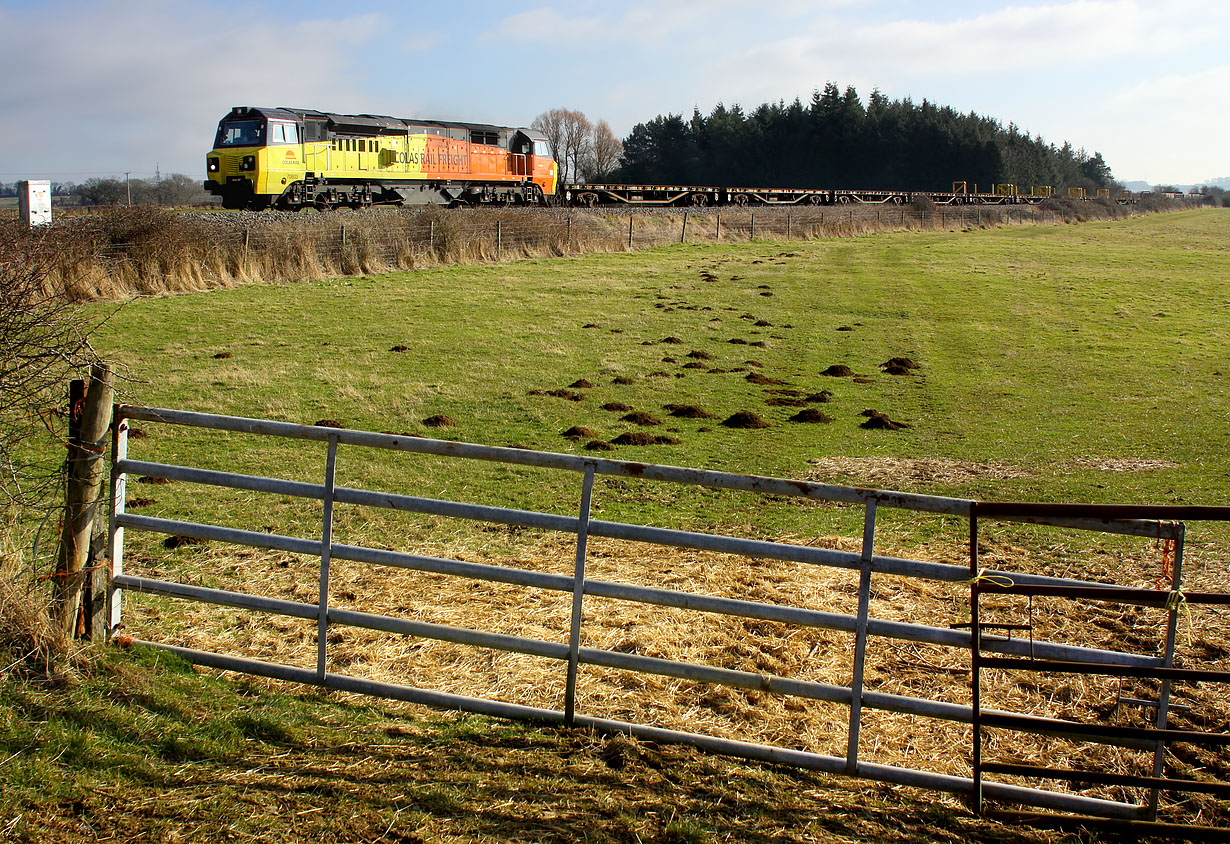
<box><xmin>0</xmin><ymin>648</ymin><xmax>1107</xmax><ymax>844</ymax></box>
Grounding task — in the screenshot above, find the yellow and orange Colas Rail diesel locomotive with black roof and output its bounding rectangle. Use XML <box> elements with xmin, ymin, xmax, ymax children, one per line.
<box><xmin>204</xmin><ymin>106</ymin><xmax>558</xmax><ymax>210</ymax></box>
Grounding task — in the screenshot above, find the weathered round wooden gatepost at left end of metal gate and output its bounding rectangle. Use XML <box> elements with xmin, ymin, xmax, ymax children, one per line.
<box><xmin>53</xmin><ymin>364</ymin><xmax>114</xmax><ymax>636</ymax></box>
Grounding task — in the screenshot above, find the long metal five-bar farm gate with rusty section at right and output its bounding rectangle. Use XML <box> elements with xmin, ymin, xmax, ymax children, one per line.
<box><xmin>107</xmin><ymin>405</ymin><xmax>1230</xmax><ymax>821</ymax></box>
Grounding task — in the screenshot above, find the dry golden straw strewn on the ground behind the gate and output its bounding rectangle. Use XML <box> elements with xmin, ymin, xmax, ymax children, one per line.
<box><xmin>125</xmin><ymin>521</ymin><xmax>1230</xmax><ymax>814</ymax></box>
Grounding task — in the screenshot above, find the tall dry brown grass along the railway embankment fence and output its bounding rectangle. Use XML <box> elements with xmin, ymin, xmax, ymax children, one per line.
<box><xmin>7</xmin><ymin>198</ymin><xmax>1183</xmax><ymax>301</ymax></box>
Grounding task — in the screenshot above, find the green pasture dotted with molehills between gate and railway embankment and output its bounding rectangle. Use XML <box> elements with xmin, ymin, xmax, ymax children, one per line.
<box><xmin>96</xmin><ymin>210</ymin><xmax>1230</xmax><ymax>561</ymax></box>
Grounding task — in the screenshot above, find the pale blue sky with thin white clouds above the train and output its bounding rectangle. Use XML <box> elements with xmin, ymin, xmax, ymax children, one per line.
<box><xmin>0</xmin><ymin>0</ymin><xmax>1230</xmax><ymax>187</ymax></box>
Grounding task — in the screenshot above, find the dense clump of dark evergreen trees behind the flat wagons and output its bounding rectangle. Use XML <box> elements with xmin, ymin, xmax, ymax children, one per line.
<box><xmin>615</xmin><ymin>82</ymin><xmax>1114</xmax><ymax>192</ymax></box>
